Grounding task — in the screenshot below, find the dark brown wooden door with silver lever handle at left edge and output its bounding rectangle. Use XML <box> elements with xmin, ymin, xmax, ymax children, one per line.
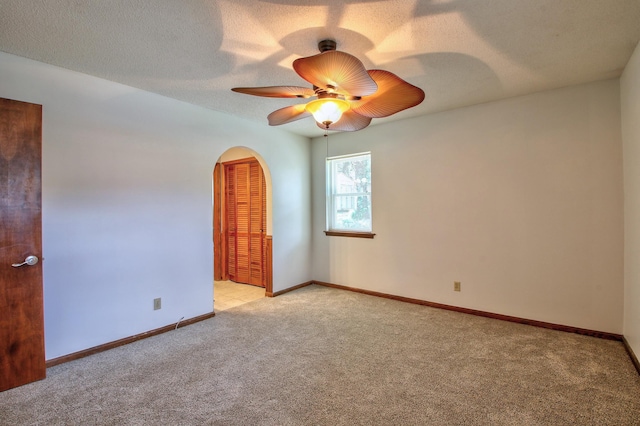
<box><xmin>0</xmin><ymin>98</ymin><xmax>46</xmax><ymax>391</ymax></box>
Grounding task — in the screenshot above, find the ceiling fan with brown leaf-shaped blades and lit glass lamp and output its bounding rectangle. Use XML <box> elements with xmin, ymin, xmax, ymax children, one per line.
<box><xmin>231</xmin><ymin>40</ymin><xmax>424</xmax><ymax>132</ymax></box>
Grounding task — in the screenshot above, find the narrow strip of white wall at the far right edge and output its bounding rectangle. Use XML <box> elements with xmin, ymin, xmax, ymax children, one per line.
<box><xmin>620</xmin><ymin>44</ymin><xmax>640</xmax><ymax>357</ymax></box>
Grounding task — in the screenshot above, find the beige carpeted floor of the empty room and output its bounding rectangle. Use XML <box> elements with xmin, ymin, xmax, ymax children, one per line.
<box><xmin>0</xmin><ymin>286</ymin><xmax>640</xmax><ymax>425</ymax></box>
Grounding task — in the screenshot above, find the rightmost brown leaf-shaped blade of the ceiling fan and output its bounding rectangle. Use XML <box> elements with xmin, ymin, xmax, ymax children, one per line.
<box><xmin>351</xmin><ymin>70</ymin><xmax>424</xmax><ymax>118</ymax></box>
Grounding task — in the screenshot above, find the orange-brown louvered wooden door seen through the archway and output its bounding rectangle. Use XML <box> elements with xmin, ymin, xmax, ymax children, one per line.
<box><xmin>224</xmin><ymin>160</ymin><xmax>266</xmax><ymax>287</ymax></box>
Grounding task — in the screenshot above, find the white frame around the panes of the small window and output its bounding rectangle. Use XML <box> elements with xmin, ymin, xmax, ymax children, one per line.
<box><xmin>324</xmin><ymin>151</ymin><xmax>375</xmax><ymax>238</ymax></box>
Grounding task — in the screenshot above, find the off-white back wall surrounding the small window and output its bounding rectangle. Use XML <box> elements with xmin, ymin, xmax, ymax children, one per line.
<box><xmin>312</xmin><ymin>76</ymin><xmax>624</xmax><ymax>333</ymax></box>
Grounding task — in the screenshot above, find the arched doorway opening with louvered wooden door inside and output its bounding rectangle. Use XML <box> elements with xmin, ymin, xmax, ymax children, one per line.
<box><xmin>213</xmin><ymin>147</ymin><xmax>273</xmax><ymax>311</ymax></box>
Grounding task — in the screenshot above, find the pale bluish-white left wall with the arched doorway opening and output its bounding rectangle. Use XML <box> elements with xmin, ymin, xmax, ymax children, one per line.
<box><xmin>0</xmin><ymin>53</ymin><xmax>311</xmax><ymax>359</ymax></box>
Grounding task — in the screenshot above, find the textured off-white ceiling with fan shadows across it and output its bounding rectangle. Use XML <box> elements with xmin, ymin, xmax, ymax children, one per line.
<box><xmin>0</xmin><ymin>0</ymin><xmax>640</xmax><ymax>137</ymax></box>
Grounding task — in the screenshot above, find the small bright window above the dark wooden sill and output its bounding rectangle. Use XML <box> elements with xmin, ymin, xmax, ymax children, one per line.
<box><xmin>326</xmin><ymin>152</ymin><xmax>373</xmax><ymax>238</ymax></box>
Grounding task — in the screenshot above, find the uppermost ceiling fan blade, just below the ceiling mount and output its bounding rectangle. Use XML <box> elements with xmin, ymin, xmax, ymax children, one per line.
<box><xmin>293</xmin><ymin>50</ymin><xmax>378</xmax><ymax>96</ymax></box>
